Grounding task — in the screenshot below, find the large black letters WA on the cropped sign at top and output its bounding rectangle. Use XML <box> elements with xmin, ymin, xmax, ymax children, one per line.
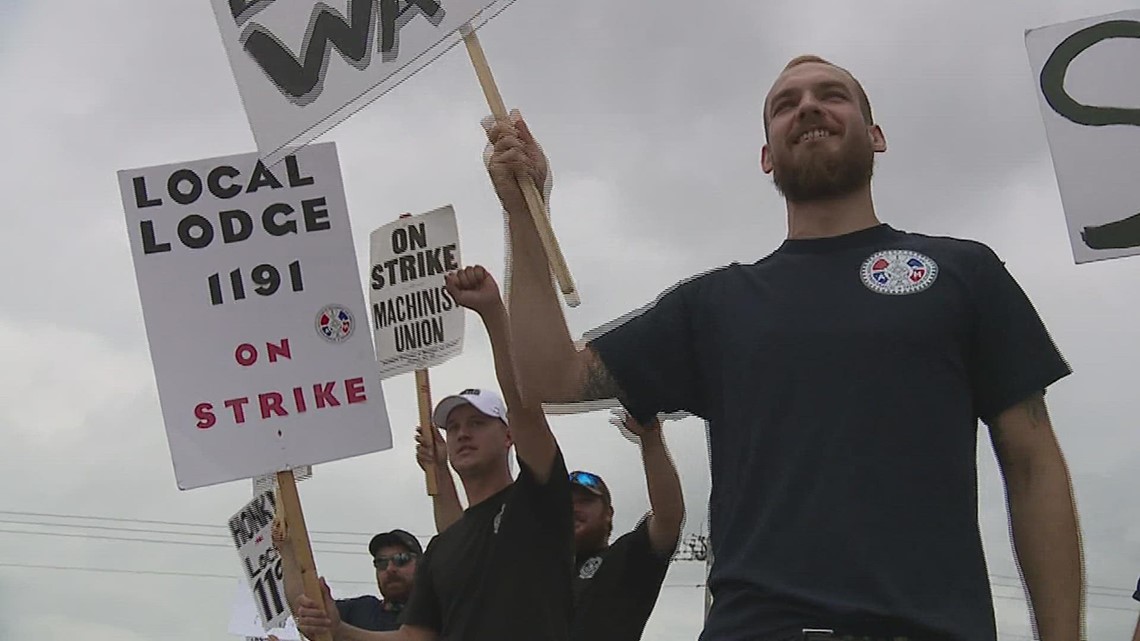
<box><xmin>241</xmin><ymin>0</ymin><xmax>446</xmax><ymax>105</ymax></box>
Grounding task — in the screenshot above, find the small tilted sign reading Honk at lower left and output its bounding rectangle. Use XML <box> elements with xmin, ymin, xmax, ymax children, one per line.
<box><xmin>228</xmin><ymin>492</ymin><xmax>290</xmax><ymax>631</ymax></box>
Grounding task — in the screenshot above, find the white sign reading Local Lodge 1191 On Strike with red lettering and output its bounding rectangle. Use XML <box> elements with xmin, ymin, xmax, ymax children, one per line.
<box><xmin>119</xmin><ymin>143</ymin><xmax>392</xmax><ymax>489</ymax></box>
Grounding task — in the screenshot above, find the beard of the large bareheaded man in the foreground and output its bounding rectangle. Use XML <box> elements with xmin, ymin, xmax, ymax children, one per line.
<box><xmin>772</xmin><ymin>134</ymin><xmax>874</xmax><ymax>203</ymax></box>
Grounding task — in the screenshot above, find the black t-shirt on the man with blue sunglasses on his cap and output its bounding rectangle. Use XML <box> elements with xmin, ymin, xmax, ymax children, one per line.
<box><xmin>570</xmin><ymin>519</ymin><xmax>670</xmax><ymax>641</ymax></box>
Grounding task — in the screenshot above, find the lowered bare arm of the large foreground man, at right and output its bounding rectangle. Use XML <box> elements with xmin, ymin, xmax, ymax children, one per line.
<box><xmin>990</xmin><ymin>392</ymin><xmax>1084</xmax><ymax>641</ymax></box>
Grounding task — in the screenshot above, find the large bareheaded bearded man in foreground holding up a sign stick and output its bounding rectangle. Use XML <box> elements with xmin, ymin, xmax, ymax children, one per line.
<box><xmin>488</xmin><ymin>56</ymin><xmax>1083</xmax><ymax>641</ymax></box>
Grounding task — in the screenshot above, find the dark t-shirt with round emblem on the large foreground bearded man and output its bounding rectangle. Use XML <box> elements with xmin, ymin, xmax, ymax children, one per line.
<box><xmin>592</xmin><ymin>225</ymin><xmax>1070</xmax><ymax>641</ymax></box>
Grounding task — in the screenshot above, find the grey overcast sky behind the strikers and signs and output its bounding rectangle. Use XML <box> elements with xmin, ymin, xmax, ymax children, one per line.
<box><xmin>0</xmin><ymin>0</ymin><xmax>1140</xmax><ymax>641</ymax></box>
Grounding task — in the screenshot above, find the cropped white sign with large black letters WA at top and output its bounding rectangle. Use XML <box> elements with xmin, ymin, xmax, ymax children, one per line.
<box><xmin>211</xmin><ymin>0</ymin><xmax>513</xmax><ymax>164</ymax></box>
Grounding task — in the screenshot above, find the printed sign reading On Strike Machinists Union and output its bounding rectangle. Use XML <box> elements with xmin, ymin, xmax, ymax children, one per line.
<box><xmin>368</xmin><ymin>205</ymin><xmax>464</xmax><ymax>378</ymax></box>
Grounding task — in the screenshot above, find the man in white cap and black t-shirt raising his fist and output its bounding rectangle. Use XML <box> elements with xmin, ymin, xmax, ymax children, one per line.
<box><xmin>296</xmin><ymin>262</ymin><xmax>573</xmax><ymax>641</ymax></box>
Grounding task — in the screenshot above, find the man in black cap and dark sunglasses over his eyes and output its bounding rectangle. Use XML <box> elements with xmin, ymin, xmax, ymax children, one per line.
<box><xmin>272</xmin><ymin>521</ymin><xmax>423</xmax><ymax>632</ymax></box>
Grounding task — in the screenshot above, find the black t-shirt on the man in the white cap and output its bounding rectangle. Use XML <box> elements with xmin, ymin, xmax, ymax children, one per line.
<box><xmin>404</xmin><ymin>451</ymin><xmax>573</xmax><ymax>641</ymax></box>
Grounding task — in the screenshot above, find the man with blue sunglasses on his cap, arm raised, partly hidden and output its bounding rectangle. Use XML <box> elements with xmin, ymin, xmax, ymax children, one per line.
<box><xmin>570</xmin><ymin>408</ymin><xmax>685</xmax><ymax>641</ymax></box>
